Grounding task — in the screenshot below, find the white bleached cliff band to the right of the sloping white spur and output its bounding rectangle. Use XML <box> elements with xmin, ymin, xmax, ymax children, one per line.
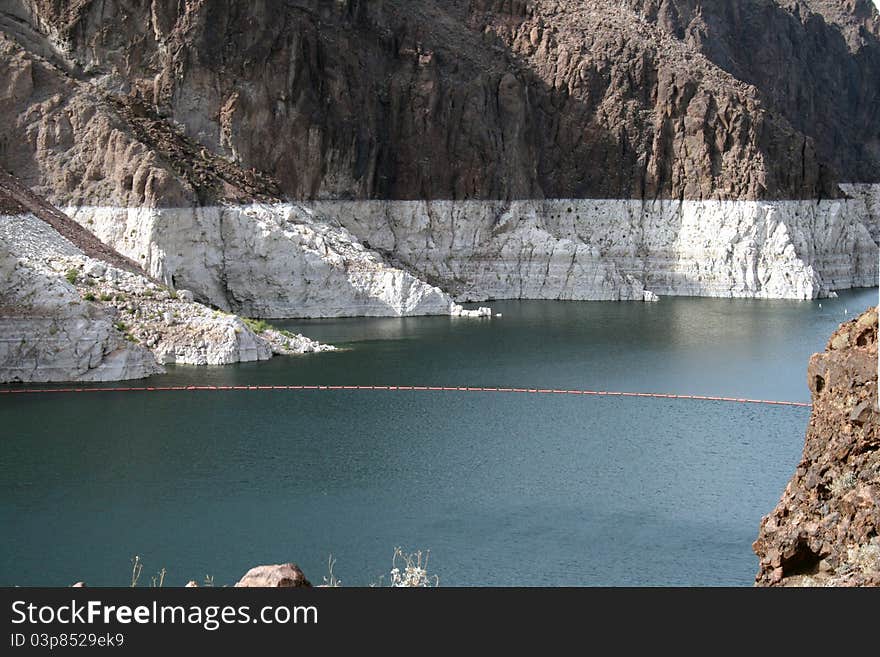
<box><xmin>324</xmin><ymin>193</ymin><xmax>880</xmax><ymax>300</ymax></box>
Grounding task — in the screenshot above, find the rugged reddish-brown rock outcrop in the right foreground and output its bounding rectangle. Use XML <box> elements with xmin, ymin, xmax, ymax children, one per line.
<box><xmin>753</xmin><ymin>308</ymin><xmax>880</xmax><ymax>586</ymax></box>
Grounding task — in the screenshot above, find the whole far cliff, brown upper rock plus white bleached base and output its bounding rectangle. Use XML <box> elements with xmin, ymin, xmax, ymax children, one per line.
<box><xmin>0</xmin><ymin>0</ymin><xmax>880</xmax><ymax>317</ymax></box>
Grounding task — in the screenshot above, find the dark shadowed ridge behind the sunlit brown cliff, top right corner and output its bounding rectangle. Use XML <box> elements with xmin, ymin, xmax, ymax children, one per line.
<box><xmin>629</xmin><ymin>0</ymin><xmax>880</xmax><ymax>192</ymax></box>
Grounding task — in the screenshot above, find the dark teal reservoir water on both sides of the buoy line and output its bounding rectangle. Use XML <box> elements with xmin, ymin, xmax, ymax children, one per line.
<box><xmin>0</xmin><ymin>289</ymin><xmax>877</xmax><ymax>586</ymax></box>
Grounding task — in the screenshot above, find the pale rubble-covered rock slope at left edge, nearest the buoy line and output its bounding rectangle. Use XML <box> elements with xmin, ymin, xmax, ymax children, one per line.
<box><xmin>0</xmin><ymin>214</ymin><xmax>332</xmax><ymax>382</ymax></box>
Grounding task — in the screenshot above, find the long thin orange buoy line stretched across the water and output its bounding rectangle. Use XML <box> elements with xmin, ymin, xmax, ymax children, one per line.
<box><xmin>0</xmin><ymin>385</ymin><xmax>813</xmax><ymax>408</ymax></box>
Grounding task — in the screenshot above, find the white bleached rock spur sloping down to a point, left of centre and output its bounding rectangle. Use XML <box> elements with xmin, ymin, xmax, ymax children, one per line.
<box><xmin>67</xmin><ymin>204</ymin><xmax>459</xmax><ymax>317</ymax></box>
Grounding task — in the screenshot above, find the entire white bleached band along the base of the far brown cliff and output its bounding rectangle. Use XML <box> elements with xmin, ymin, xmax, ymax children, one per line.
<box><xmin>66</xmin><ymin>191</ymin><xmax>880</xmax><ymax>318</ymax></box>
